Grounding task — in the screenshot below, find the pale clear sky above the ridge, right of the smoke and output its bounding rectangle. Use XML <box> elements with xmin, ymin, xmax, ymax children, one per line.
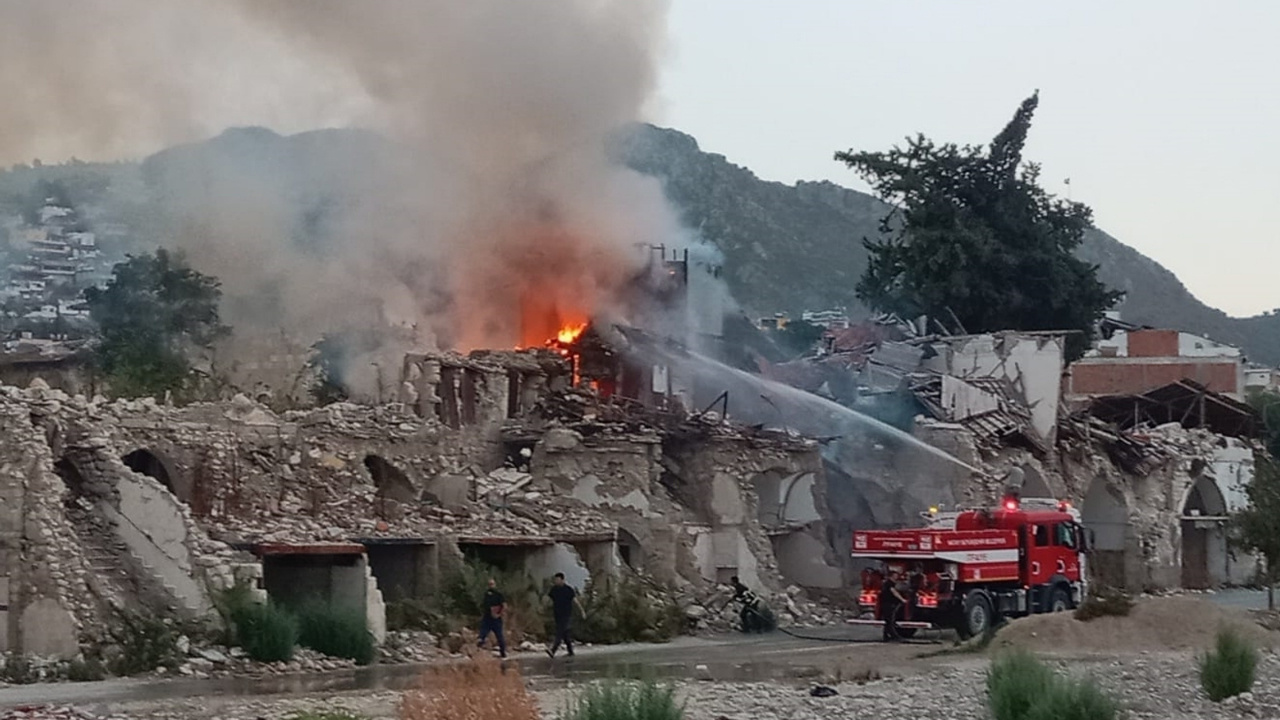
<box><xmin>657</xmin><ymin>0</ymin><xmax>1280</xmax><ymax>315</ymax></box>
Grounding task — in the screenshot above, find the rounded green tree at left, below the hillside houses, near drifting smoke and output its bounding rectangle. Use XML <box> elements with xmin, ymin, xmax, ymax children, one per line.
<box><xmin>84</xmin><ymin>249</ymin><xmax>229</xmax><ymax>396</ymax></box>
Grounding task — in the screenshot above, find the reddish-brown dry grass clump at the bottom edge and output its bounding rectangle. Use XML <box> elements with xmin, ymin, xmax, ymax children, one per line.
<box><xmin>399</xmin><ymin>652</ymin><xmax>540</xmax><ymax>720</ymax></box>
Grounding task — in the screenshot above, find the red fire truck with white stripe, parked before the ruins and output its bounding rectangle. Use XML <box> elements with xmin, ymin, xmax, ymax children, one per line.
<box><xmin>852</xmin><ymin>492</ymin><xmax>1092</xmax><ymax>638</ymax></box>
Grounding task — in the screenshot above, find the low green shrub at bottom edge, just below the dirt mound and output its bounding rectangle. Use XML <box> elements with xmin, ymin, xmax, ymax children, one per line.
<box><xmin>987</xmin><ymin>651</ymin><xmax>1120</xmax><ymax>720</ymax></box>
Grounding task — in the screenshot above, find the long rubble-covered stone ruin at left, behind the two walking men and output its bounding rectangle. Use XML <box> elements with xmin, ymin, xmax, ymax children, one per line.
<box><xmin>0</xmin><ymin>335</ymin><xmax>838</xmax><ymax>656</ymax></box>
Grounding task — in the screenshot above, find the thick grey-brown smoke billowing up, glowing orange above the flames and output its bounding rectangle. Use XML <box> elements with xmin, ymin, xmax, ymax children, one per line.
<box><xmin>0</xmin><ymin>0</ymin><xmax>677</xmax><ymax>392</ymax></box>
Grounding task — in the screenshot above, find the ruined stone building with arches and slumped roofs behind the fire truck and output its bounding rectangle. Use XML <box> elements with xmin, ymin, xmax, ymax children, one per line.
<box><xmin>762</xmin><ymin>318</ymin><xmax>1262</xmax><ymax>591</ymax></box>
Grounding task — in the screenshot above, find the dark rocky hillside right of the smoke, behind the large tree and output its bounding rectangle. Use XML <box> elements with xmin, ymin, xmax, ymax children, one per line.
<box><xmin>620</xmin><ymin>126</ymin><xmax>1280</xmax><ymax>365</ymax></box>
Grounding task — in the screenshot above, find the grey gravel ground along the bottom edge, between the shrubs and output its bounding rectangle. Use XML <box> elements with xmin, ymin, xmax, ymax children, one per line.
<box><xmin>12</xmin><ymin>651</ymin><xmax>1280</xmax><ymax>720</ymax></box>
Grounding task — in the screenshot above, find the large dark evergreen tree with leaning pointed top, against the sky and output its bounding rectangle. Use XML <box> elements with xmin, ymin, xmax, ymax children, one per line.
<box><xmin>836</xmin><ymin>92</ymin><xmax>1123</xmax><ymax>357</ymax></box>
